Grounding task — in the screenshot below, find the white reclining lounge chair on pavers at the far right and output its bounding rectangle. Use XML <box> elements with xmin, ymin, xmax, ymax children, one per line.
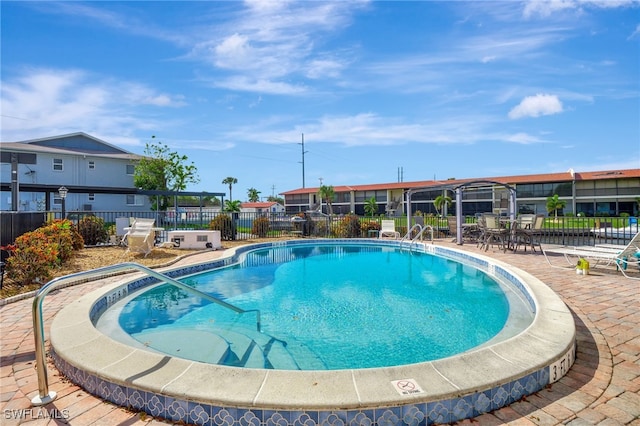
<box><xmin>541</xmin><ymin>232</ymin><xmax>640</xmax><ymax>279</ymax></box>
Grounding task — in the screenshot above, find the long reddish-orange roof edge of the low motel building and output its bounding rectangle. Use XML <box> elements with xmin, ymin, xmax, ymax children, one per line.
<box><xmin>281</xmin><ymin>169</ymin><xmax>640</xmax><ymax>195</ymax></box>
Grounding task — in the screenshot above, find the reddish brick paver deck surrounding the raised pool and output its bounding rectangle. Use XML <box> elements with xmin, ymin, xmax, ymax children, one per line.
<box><xmin>0</xmin><ymin>241</ymin><xmax>640</xmax><ymax>426</ymax></box>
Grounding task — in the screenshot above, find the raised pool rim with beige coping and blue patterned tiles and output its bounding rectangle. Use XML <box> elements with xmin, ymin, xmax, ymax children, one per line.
<box><xmin>50</xmin><ymin>240</ymin><xmax>575</xmax><ymax>425</ymax></box>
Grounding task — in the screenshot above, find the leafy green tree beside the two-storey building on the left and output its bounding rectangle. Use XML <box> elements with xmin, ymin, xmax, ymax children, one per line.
<box><xmin>133</xmin><ymin>136</ymin><xmax>200</xmax><ymax>211</ymax></box>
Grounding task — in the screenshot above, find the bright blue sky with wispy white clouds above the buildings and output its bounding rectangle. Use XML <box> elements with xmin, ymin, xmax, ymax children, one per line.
<box><xmin>0</xmin><ymin>0</ymin><xmax>640</xmax><ymax>198</ymax></box>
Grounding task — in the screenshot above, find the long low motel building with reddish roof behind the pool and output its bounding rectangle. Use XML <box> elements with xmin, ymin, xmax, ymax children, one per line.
<box><xmin>281</xmin><ymin>169</ymin><xmax>640</xmax><ymax>216</ymax></box>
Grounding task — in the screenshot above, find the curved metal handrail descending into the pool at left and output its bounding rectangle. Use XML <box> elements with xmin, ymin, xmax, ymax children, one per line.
<box><xmin>31</xmin><ymin>262</ymin><xmax>261</xmax><ymax>406</ymax></box>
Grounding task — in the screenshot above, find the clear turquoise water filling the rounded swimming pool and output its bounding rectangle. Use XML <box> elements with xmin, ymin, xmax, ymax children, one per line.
<box><xmin>111</xmin><ymin>244</ymin><xmax>510</xmax><ymax>369</ymax></box>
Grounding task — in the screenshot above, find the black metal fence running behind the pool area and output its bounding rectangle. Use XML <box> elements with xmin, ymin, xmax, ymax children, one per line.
<box><xmin>0</xmin><ymin>209</ymin><xmax>638</xmax><ymax>245</ymax></box>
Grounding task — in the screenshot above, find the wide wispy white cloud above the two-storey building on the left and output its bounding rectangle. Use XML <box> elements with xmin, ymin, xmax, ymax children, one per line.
<box><xmin>0</xmin><ymin>69</ymin><xmax>184</xmax><ymax>141</ymax></box>
